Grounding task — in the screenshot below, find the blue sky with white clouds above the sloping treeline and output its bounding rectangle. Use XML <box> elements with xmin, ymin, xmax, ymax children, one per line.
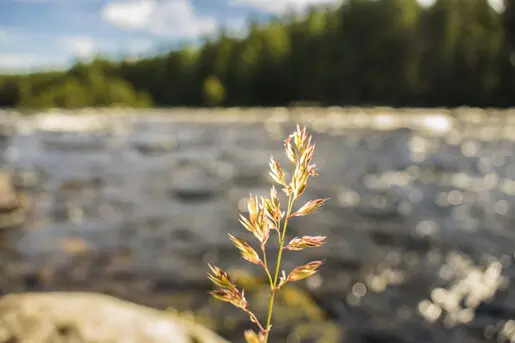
<box><xmin>0</xmin><ymin>0</ymin><xmax>508</xmax><ymax>72</ymax></box>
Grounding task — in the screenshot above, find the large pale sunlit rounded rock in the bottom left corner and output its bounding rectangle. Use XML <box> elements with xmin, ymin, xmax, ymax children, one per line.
<box><xmin>0</xmin><ymin>292</ymin><xmax>228</xmax><ymax>343</ymax></box>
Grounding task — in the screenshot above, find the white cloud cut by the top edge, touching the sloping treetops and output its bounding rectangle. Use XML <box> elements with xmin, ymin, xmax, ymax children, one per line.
<box><xmin>231</xmin><ymin>0</ymin><xmax>342</xmax><ymax>13</ymax></box>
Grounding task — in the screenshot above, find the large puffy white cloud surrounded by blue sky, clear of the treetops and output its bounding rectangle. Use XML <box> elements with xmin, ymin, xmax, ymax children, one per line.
<box><xmin>102</xmin><ymin>0</ymin><xmax>216</xmax><ymax>38</ymax></box>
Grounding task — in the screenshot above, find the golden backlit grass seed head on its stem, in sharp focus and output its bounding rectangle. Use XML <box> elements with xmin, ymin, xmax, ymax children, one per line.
<box><xmin>208</xmin><ymin>125</ymin><xmax>328</xmax><ymax>343</ymax></box>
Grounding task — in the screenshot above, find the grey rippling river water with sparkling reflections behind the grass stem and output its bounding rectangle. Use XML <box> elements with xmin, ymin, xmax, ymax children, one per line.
<box><xmin>0</xmin><ymin>109</ymin><xmax>515</xmax><ymax>343</ymax></box>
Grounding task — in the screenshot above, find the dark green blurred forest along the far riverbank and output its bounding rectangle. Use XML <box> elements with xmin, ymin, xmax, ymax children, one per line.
<box><xmin>0</xmin><ymin>0</ymin><xmax>515</xmax><ymax>108</ymax></box>
